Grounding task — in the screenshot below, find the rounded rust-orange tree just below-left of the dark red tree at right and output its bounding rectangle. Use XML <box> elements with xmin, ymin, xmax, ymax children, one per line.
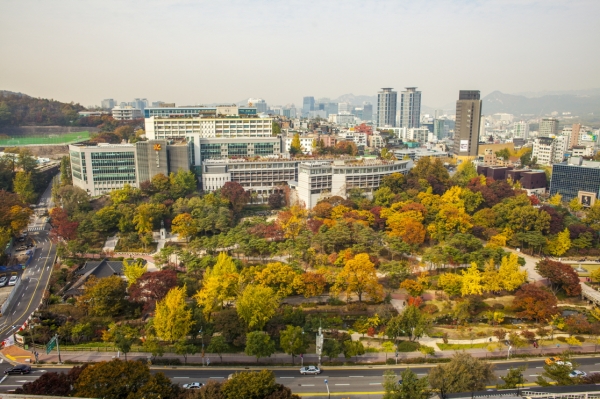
<box><xmin>512</xmin><ymin>284</ymin><xmax>558</xmax><ymax>322</ymax></box>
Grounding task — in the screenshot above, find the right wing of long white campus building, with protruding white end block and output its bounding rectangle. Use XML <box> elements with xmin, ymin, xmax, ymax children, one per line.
<box><xmin>292</xmin><ymin>159</ymin><xmax>413</xmax><ymax>209</ymax></box>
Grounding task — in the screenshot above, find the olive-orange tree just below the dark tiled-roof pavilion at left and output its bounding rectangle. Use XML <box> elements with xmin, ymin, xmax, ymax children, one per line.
<box><xmin>79</xmin><ymin>276</ymin><xmax>126</xmax><ymax>316</ymax></box>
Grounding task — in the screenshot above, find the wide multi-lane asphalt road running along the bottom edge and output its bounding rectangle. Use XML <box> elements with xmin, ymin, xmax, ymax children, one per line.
<box><xmin>0</xmin><ymin>357</ymin><xmax>600</xmax><ymax>399</ymax></box>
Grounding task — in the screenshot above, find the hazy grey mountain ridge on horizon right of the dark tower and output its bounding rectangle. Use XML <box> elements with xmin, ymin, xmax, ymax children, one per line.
<box><xmin>483</xmin><ymin>91</ymin><xmax>600</xmax><ymax>116</ymax></box>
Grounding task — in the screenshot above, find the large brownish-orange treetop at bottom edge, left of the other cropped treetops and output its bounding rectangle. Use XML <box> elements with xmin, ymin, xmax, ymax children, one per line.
<box><xmin>74</xmin><ymin>359</ymin><xmax>179</xmax><ymax>399</ymax></box>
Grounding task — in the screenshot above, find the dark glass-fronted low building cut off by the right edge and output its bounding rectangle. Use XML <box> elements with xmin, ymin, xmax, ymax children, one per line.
<box><xmin>550</xmin><ymin>157</ymin><xmax>600</xmax><ymax>206</ymax></box>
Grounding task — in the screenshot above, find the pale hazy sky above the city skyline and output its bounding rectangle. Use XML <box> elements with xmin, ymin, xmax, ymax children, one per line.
<box><xmin>0</xmin><ymin>0</ymin><xmax>600</xmax><ymax>107</ymax></box>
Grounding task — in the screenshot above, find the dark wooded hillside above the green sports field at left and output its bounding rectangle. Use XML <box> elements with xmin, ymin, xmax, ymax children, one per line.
<box><xmin>0</xmin><ymin>90</ymin><xmax>85</xmax><ymax>126</ymax></box>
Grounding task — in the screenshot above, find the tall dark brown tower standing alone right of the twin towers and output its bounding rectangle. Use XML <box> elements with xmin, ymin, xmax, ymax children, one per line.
<box><xmin>453</xmin><ymin>90</ymin><xmax>481</xmax><ymax>157</ymax></box>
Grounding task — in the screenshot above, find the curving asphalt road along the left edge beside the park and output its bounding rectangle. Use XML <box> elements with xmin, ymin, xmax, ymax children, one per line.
<box><xmin>0</xmin><ymin>180</ymin><xmax>56</xmax><ymax>346</ymax></box>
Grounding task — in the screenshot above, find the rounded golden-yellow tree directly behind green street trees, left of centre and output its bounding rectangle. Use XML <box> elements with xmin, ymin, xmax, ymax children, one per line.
<box><xmin>236</xmin><ymin>285</ymin><xmax>279</xmax><ymax>330</ymax></box>
